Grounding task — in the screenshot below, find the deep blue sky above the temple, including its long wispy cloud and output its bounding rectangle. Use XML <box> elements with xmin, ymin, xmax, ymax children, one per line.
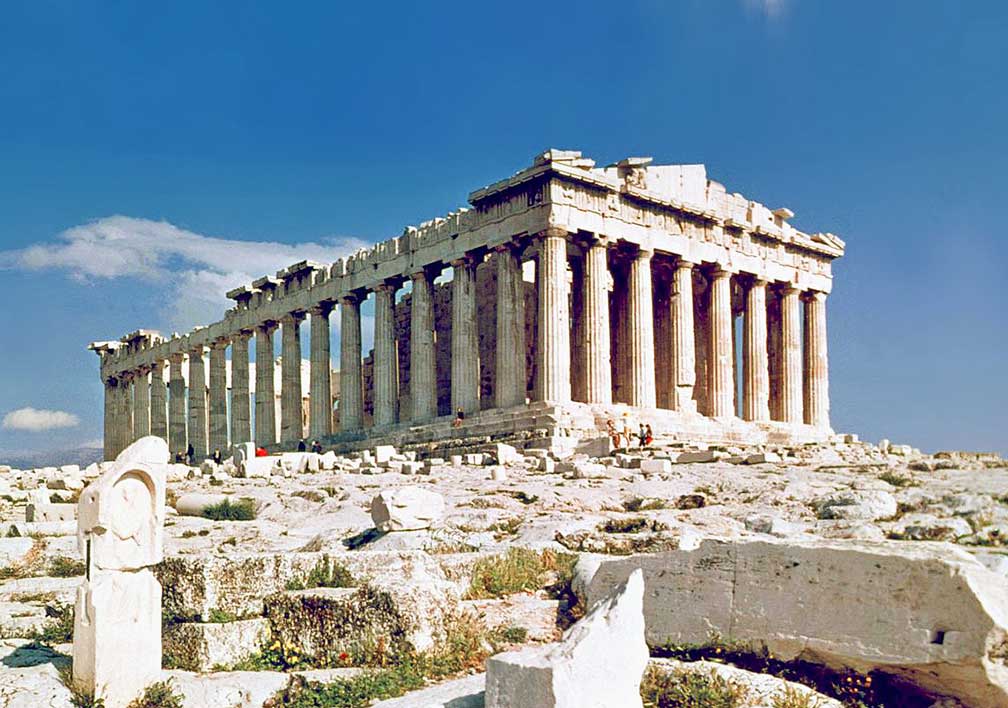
<box><xmin>0</xmin><ymin>0</ymin><xmax>1008</xmax><ymax>453</ymax></box>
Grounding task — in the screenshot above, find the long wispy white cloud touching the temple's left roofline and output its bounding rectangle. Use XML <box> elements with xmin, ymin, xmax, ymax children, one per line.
<box><xmin>0</xmin><ymin>216</ymin><xmax>367</xmax><ymax>331</ymax></box>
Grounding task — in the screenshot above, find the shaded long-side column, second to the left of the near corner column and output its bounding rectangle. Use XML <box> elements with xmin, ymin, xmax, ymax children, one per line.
<box><xmin>452</xmin><ymin>257</ymin><xmax>480</xmax><ymax>416</ymax></box>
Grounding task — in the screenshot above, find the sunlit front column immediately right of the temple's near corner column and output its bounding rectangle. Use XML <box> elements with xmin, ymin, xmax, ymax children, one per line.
<box><xmin>577</xmin><ymin>237</ymin><xmax>613</xmax><ymax>403</ymax></box>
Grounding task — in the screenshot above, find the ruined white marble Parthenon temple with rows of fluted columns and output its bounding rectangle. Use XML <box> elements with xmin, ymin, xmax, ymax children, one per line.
<box><xmin>91</xmin><ymin>149</ymin><xmax>845</xmax><ymax>459</ymax></box>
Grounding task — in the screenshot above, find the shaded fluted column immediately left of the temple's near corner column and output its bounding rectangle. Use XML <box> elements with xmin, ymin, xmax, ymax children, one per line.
<box><xmin>494</xmin><ymin>244</ymin><xmax>526</xmax><ymax>408</ymax></box>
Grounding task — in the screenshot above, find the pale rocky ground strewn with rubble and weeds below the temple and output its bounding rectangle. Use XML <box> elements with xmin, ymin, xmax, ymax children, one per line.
<box><xmin>0</xmin><ymin>441</ymin><xmax>1008</xmax><ymax>708</ymax></box>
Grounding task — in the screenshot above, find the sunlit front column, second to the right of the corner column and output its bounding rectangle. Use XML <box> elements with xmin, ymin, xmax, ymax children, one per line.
<box><xmin>627</xmin><ymin>248</ymin><xmax>657</xmax><ymax>408</ymax></box>
